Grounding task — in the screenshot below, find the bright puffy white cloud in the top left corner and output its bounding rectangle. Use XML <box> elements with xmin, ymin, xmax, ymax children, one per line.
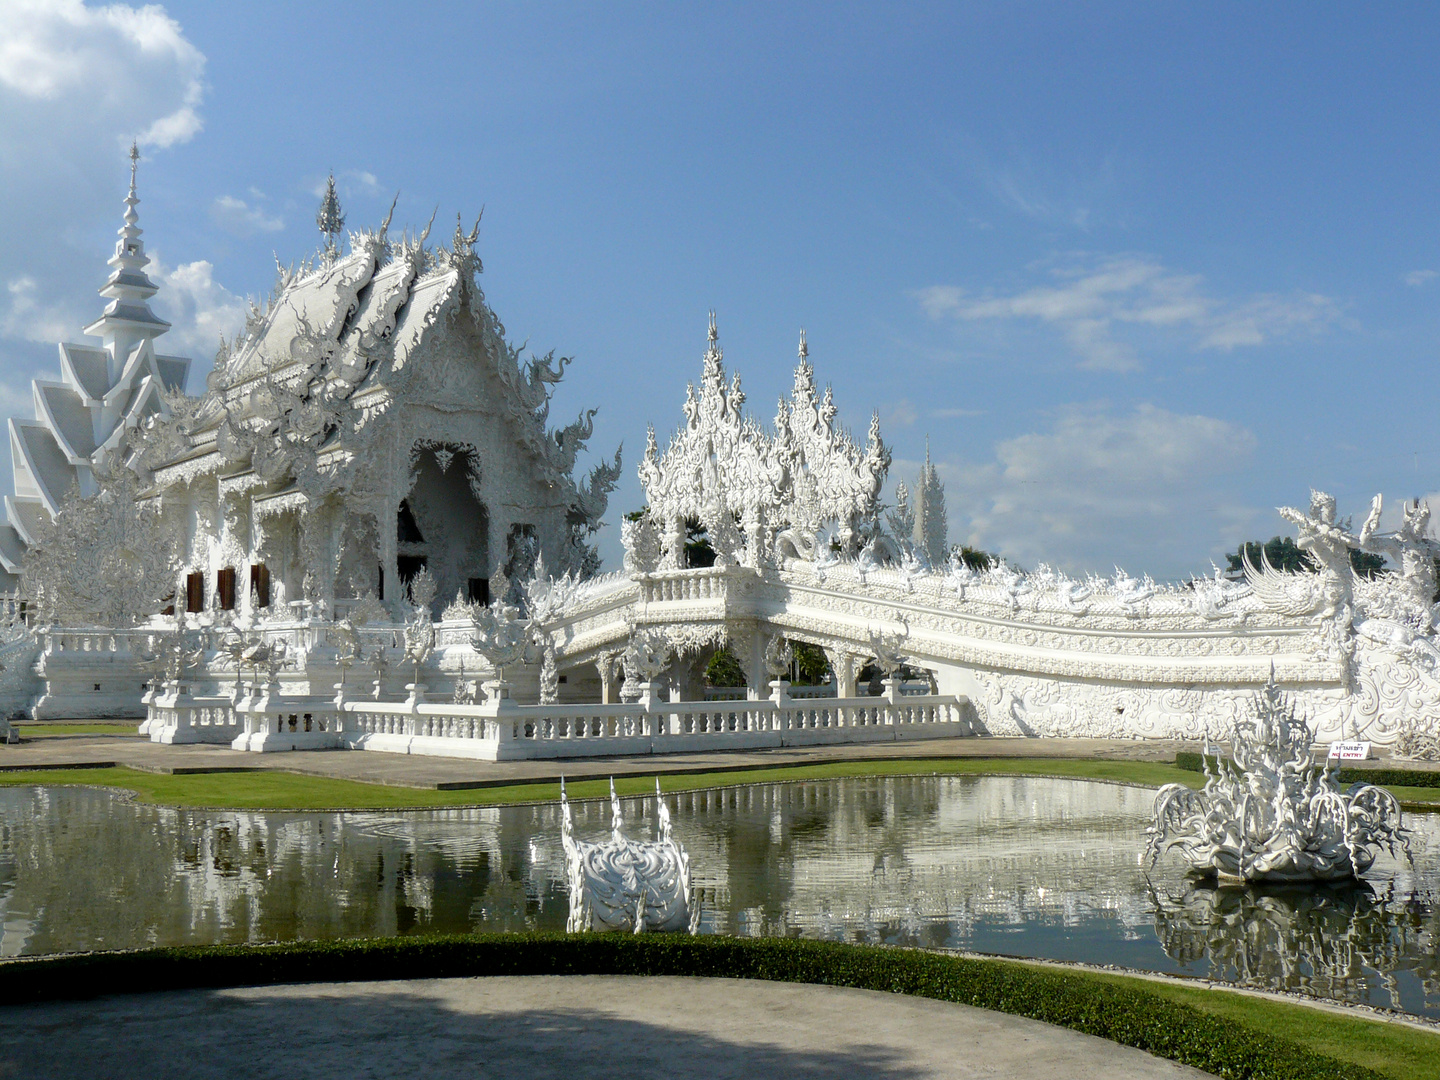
<box><xmin>0</xmin><ymin>0</ymin><xmax>204</xmax><ymax>147</ymax></box>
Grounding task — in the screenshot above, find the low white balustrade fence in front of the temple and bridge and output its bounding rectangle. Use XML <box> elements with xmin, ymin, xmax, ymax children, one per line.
<box><xmin>145</xmin><ymin>683</ymin><xmax>975</xmax><ymax>762</ymax></box>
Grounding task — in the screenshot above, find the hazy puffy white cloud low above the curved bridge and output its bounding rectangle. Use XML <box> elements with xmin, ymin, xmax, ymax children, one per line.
<box><xmin>940</xmin><ymin>405</ymin><xmax>1263</xmax><ymax>577</ymax></box>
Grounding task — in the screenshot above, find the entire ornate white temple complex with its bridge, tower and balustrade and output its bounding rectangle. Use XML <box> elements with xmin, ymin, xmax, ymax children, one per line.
<box><xmin>8</xmin><ymin>154</ymin><xmax>1440</xmax><ymax>760</ymax></box>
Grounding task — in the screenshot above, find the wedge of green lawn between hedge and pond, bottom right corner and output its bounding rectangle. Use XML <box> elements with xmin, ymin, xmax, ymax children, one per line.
<box><xmin>1082</xmin><ymin>965</ymin><xmax>1440</xmax><ymax>1080</ymax></box>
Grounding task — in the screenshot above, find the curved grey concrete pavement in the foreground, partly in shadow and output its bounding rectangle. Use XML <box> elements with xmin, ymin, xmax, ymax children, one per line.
<box><xmin>0</xmin><ymin>976</ymin><xmax>1208</xmax><ymax>1080</ymax></box>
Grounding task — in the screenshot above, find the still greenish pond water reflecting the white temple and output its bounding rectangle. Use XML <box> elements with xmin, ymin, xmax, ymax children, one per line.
<box><xmin>0</xmin><ymin>776</ymin><xmax>1440</xmax><ymax>1017</ymax></box>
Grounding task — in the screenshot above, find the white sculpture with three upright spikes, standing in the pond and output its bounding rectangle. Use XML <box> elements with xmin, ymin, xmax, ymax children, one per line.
<box><xmin>560</xmin><ymin>779</ymin><xmax>694</xmax><ymax>933</ymax></box>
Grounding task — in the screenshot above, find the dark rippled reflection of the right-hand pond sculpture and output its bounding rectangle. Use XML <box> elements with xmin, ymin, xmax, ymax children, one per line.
<box><xmin>1155</xmin><ymin>883</ymin><xmax>1440</xmax><ymax>1008</ymax></box>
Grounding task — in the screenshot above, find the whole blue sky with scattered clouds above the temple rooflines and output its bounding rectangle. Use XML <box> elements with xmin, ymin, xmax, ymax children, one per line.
<box><xmin>0</xmin><ymin>0</ymin><xmax>1440</xmax><ymax>577</ymax></box>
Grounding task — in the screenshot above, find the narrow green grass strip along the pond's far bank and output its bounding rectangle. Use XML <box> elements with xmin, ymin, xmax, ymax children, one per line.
<box><xmin>0</xmin><ymin>757</ymin><xmax>1201</xmax><ymax>811</ymax></box>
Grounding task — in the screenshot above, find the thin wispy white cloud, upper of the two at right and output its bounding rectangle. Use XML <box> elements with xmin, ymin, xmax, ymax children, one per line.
<box><xmin>919</xmin><ymin>255</ymin><xmax>1339</xmax><ymax>372</ymax></box>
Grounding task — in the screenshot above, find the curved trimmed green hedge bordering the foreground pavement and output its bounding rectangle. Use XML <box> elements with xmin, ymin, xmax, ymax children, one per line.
<box><xmin>0</xmin><ymin>935</ymin><xmax>1380</xmax><ymax>1080</ymax></box>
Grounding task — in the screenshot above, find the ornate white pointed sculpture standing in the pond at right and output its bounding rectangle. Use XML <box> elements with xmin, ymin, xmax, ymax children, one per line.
<box><xmin>1148</xmin><ymin>680</ymin><xmax>1408</xmax><ymax>883</ymax></box>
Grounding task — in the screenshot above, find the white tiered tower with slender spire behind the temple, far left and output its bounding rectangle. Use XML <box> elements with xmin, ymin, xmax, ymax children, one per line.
<box><xmin>0</xmin><ymin>145</ymin><xmax>190</xmax><ymax>590</ymax></box>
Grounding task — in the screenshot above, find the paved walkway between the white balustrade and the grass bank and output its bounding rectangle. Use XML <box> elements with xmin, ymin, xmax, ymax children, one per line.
<box><xmin>0</xmin><ymin>729</ymin><xmax>1198</xmax><ymax>789</ymax></box>
